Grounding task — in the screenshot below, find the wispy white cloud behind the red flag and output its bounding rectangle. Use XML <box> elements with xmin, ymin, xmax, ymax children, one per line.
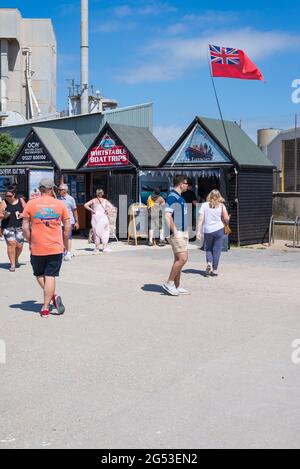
<box><xmin>122</xmin><ymin>28</ymin><xmax>300</xmax><ymax>84</ymax></box>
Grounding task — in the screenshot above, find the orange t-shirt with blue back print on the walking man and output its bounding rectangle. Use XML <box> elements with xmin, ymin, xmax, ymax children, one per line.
<box><xmin>23</xmin><ymin>195</ymin><xmax>70</xmax><ymax>256</ymax></box>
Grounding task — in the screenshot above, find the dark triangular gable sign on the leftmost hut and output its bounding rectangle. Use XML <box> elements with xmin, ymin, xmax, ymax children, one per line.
<box><xmin>16</xmin><ymin>133</ymin><xmax>53</xmax><ymax>166</ymax></box>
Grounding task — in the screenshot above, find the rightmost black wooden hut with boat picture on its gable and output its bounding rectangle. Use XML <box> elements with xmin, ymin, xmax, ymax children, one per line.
<box><xmin>157</xmin><ymin>117</ymin><xmax>273</xmax><ymax>245</ymax></box>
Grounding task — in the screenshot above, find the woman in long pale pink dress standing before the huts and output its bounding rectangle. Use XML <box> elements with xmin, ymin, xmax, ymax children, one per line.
<box><xmin>84</xmin><ymin>189</ymin><xmax>113</xmax><ymax>252</ymax></box>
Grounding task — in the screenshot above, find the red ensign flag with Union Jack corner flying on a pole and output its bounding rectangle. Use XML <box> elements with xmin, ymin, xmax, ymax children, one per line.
<box><xmin>209</xmin><ymin>45</ymin><xmax>264</xmax><ymax>80</ymax></box>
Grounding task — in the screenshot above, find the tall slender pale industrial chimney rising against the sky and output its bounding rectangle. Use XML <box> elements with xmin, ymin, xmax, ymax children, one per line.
<box><xmin>80</xmin><ymin>0</ymin><xmax>89</xmax><ymax>114</ymax></box>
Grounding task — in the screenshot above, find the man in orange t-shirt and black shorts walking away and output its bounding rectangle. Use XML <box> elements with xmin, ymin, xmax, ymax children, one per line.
<box><xmin>23</xmin><ymin>179</ymin><xmax>71</xmax><ymax>317</ymax></box>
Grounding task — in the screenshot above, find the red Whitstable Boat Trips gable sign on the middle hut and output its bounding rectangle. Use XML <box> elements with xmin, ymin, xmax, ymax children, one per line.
<box><xmin>87</xmin><ymin>134</ymin><xmax>129</xmax><ymax>167</ymax></box>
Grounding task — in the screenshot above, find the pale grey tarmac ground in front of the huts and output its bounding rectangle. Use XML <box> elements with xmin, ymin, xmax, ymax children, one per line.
<box><xmin>0</xmin><ymin>240</ymin><xmax>300</xmax><ymax>449</ymax></box>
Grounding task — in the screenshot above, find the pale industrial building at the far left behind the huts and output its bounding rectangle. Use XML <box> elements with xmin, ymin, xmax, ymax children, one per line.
<box><xmin>0</xmin><ymin>8</ymin><xmax>56</xmax><ymax>126</ymax></box>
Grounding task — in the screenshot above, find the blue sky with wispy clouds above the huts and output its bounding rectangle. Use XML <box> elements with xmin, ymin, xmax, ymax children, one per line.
<box><xmin>0</xmin><ymin>0</ymin><xmax>300</xmax><ymax>146</ymax></box>
